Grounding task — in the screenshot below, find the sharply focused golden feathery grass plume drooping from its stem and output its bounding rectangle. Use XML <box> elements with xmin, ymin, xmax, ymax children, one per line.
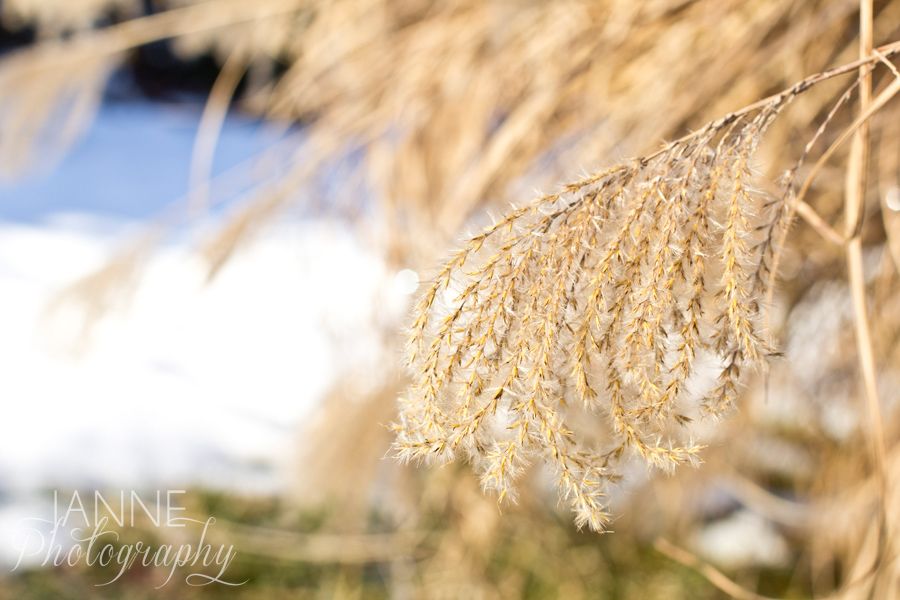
<box><xmin>395</xmin><ymin>45</ymin><xmax>900</xmax><ymax>531</ymax></box>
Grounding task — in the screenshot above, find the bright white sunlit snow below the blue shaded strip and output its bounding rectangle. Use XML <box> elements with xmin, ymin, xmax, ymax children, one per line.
<box><xmin>0</xmin><ymin>213</ymin><xmax>405</xmax><ymax>492</ymax></box>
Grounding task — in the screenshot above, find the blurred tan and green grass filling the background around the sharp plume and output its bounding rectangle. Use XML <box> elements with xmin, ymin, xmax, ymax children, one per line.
<box><xmin>0</xmin><ymin>0</ymin><xmax>900</xmax><ymax>599</ymax></box>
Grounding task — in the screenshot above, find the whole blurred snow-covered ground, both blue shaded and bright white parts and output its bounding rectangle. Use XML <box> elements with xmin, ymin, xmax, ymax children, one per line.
<box><xmin>0</xmin><ymin>99</ymin><xmax>411</xmax><ymax>502</ymax></box>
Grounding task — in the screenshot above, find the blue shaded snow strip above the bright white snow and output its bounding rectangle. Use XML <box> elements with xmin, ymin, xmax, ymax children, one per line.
<box><xmin>0</xmin><ymin>100</ymin><xmax>285</xmax><ymax>223</ymax></box>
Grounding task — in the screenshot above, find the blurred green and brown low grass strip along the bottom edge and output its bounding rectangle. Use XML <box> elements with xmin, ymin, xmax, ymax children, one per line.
<box><xmin>0</xmin><ymin>486</ymin><xmax>799</xmax><ymax>600</ymax></box>
